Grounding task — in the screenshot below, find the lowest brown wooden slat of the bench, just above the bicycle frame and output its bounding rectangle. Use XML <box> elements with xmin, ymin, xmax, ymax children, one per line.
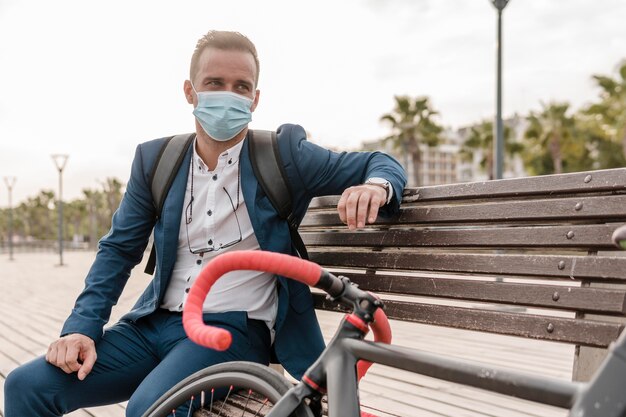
<box><xmin>314</xmin><ymin>294</ymin><xmax>624</xmax><ymax>347</ymax></box>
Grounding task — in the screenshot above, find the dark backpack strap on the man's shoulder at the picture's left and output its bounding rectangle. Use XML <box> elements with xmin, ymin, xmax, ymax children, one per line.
<box><xmin>144</xmin><ymin>133</ymin><xmax>196</xmax><ymax>275</ymax></box>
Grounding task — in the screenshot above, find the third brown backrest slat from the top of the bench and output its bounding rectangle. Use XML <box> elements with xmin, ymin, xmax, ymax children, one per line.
<box><xmin>301</xmin><ymin>223</ymin><xmax>621</xmax><ymax>250</ymax></box>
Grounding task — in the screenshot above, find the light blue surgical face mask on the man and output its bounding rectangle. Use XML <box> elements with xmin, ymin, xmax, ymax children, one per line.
<box><xmin>191</xmin><ymin>84</ymin><xmax>252</xmax><ymax>142</ymax></box>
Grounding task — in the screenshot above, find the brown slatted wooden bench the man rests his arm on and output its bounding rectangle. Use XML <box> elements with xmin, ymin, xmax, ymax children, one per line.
<box><xmin>300</xmin><ymin>169</ymin><xmax>626</xmax><ymax>381</ymax></box>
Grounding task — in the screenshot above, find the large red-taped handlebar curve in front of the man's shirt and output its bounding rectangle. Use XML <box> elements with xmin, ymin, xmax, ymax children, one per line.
<box><xmin>183</xmin><ymin>250</ymin><xmax>322</xmax><ymax>351</ymax></box>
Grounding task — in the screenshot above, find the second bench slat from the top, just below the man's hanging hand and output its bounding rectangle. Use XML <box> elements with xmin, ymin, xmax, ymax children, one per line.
<box><xmin>301</xmin><ymin>195</ymin><xmax>626</xmax><ymax>227</ymax></box>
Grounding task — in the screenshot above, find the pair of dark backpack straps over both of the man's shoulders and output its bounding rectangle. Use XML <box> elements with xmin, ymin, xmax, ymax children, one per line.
<box><xmin>145</xmin><ymin>130</ymin><xmax>309</xmax><ymax>275</ymax></box>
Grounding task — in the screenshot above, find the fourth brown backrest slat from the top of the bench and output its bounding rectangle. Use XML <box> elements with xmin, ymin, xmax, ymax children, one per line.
<box><xmin>309</xmin><ymin>248</ymin><xmax>626</xmax><ymax>281</ymax></box>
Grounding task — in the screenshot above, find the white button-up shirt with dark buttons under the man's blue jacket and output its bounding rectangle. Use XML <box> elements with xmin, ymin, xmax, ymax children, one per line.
<box><xmin>161</xmin><ymin>140</ymin><xmax>278</xmax><ymax>333</ymax></box>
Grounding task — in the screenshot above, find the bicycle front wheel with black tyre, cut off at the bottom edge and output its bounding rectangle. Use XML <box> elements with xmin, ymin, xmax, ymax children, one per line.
<box><xmin>143</xmin><ymin>362</ymin><xmax>313</xmax><ymax>417</ymax></box>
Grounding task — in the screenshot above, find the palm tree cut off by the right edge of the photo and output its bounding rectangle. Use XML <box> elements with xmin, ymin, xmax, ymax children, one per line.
<box><xmin>587</xmin><ymin>61</ymin><xmax>626</xmax><ymax>158</ymax></box>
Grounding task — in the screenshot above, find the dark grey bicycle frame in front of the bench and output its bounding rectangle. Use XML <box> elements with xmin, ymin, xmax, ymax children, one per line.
<box><xmin>267</xmin><ymin>310</ymin><xmax>626</xmax><ymax>417</ymax></box>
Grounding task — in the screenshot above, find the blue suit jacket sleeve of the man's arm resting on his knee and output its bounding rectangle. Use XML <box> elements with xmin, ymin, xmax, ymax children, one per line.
<box><xmin>61</xmin><ymin>145</ymin><xmax>155</xmax><ymax>341</ymax></box>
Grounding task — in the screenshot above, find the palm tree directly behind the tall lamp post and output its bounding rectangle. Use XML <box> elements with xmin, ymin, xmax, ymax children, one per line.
<box><xmin>460</xmin><ymin>120</ymin><xmax>523</xmax><ymax>180</ymax></box>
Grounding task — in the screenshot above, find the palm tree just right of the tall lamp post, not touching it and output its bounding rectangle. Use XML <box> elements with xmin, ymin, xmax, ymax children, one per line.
<box><xmin>524</xmin><ymin>102</ymin><xmax>575</xmax><ymax>175</ymax></box>
